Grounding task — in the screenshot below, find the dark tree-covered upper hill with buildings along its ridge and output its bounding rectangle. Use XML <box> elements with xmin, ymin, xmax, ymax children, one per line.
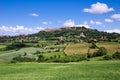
<box><xmin>0</xmin><ymin>26</ymin><xmax>120</xmax><ymax>44</ymax></box>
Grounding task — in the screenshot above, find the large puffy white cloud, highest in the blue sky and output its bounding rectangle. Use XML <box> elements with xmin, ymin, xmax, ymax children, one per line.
<box><xmin>83</xmin><ymin>2</ymin><xmax>114</xmax><ymax>14</ymax></box>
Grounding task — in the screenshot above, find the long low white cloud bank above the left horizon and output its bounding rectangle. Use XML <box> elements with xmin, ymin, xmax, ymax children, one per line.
<box><xmin>0</xmin><ymin>25</ymin><xmax>44</xmax><ymax>35</ymax></box>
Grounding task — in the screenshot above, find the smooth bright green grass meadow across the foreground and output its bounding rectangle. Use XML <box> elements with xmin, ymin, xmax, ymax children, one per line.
<box><xmin>0</xmin><ymin>61</ymin><xmax>120</xmax><ymax>80</ymax></box>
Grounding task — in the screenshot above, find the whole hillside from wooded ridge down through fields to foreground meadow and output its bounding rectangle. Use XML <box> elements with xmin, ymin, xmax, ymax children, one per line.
<box><xmin>0</xmin><ymin>26</ymin><xmax>120</xmax><ymax>62</ymax></box>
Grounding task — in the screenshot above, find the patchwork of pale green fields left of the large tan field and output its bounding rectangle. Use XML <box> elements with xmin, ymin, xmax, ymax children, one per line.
<box><xmin>0</xmin><ymin>45</ymin><xmax>64</xmax><ymax>62</ymax></box>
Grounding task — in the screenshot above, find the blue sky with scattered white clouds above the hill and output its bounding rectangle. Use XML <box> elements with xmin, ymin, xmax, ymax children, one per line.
<box><xmin>0</xmin><ymin>0</ymin><xmax>120</xmax><ymax>35</ymax></box>
